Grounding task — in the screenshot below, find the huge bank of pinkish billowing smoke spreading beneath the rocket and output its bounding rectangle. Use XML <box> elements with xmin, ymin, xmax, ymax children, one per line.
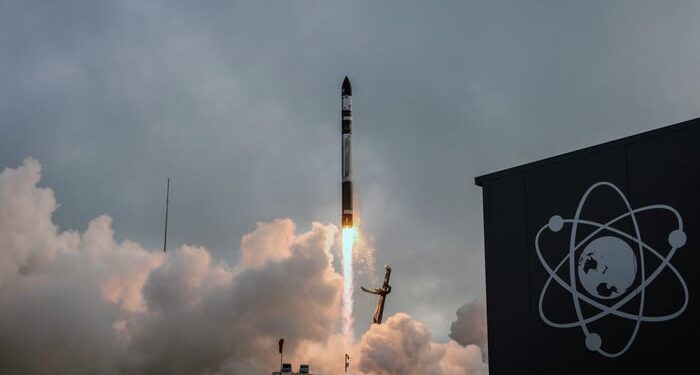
<box><xmin>0</xmin><ymin>159</ymin><xmax>485</xmax><ymax>375</ymax></box>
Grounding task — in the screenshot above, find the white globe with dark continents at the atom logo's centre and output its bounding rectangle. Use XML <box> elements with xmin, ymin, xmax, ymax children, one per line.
<box><xmin>578</xmin><ymin>236</ymin><xmax>637</xmax><ymax>299</ymax></box>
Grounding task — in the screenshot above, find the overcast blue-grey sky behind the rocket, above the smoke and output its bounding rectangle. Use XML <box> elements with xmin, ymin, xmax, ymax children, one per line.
<box><xmin>0</xmin><ymin>0</ymin><xmax>700</xmax><ymax>339</ymax></box>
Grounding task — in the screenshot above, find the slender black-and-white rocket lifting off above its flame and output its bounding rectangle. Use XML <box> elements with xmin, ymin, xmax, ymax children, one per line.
<box><xmin>340</xmin><ymin>76</ymin><xmax>353</xmax><ymax>228</ymax></box>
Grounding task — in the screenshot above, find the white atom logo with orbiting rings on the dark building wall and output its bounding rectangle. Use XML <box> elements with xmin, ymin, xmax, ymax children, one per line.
<box><xmin>535</xmin><ymin>182</ymin><xmax>688</xmax><ymax>358</ymax></box>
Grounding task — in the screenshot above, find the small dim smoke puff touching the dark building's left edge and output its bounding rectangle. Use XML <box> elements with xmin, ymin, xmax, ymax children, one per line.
<box><xmin>449</xmin><ymin>299</ymin><xmax>487</xmax><ymax>353</ymax></box>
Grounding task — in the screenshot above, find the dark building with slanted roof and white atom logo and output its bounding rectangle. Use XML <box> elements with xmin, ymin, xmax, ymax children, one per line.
<box><xmin>476</xmin><ymin>119</ymin><xmax>700</xmax><ymax>375</ymax></box>
